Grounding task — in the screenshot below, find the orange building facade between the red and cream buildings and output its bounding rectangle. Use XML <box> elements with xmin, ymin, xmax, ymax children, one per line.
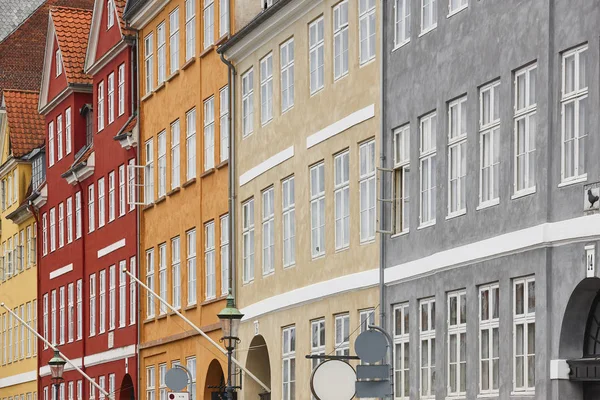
<box><xmin>125</xmin><ymin>0</ymin><xmax>233</xmax><ymax>400</ymax></box>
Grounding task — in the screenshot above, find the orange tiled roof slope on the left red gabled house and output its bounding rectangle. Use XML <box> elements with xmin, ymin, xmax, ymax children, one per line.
<box><xmin>50</xmin><ymin>7</ymin><xmax>92</xmax><ymax>84</ymax></box>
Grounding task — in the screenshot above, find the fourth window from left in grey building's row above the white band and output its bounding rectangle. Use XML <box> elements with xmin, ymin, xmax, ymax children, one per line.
<box><xmin>479</xmin><ymin>81</ymin><xmax>500</xmax><ymax>207</ymax></box>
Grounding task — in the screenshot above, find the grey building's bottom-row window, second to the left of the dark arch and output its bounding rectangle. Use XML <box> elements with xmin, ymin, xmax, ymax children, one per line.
<box><xmin>479</xmin><ymin>284</ymin><xmax>500</xmax><ymax>394</ymax></box>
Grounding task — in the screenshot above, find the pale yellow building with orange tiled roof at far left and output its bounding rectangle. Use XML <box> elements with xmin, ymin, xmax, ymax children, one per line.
<box><xmin>0</xmin><ymin>90</ymin><xmax>44</xmax><ymax>400</ymax></box>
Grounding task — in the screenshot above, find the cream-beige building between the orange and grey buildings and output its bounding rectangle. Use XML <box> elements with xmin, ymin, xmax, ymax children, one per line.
<box><xmin>219</xmin><ymin>0</ymin><xmax>380</xmax><ymax>400</ymax></box>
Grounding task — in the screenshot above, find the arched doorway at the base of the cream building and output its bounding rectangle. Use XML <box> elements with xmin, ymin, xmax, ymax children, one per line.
<box><xmin>242</xmin><ymin>335</ymin><xmax>271</xmax><ymax>400</ymax></box>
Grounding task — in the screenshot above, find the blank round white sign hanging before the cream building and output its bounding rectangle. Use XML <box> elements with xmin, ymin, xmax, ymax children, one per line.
<box><xmin>310</xmin><ymin>360</ymin><xmax>356</xmax><ymax>400</ymax></box>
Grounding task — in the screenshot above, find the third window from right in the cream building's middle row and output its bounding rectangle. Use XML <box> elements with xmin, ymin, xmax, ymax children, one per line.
<box><xmin>310</xmin><ymin>162</ymin><xmax>325</xmax><ymax>258</ymax></box>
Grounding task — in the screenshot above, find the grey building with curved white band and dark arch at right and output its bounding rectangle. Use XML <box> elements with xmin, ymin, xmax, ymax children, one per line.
<box><xmin>379</xmin><ymin>0</ymin><xmax>600</xmax><ymax>400</ymax></box>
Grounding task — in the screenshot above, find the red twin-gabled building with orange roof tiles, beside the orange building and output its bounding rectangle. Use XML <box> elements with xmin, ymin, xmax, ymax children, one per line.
<box><xmin>34</xmin><ymin>0</ymin><xmax>138</xmax><ymax>400</ymax></box>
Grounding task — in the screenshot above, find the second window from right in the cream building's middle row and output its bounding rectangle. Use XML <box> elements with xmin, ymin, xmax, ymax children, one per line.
<box><xmin>333</xmin><ymin>150</ymin><xmax>350</xmax><ymax>250</ymax></box>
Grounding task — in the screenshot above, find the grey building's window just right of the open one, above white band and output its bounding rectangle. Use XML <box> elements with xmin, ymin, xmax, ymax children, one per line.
<box><xmin>419</xmin><ymin>112</ymin><xmax>437</xmax><ymax>225</ymax></box>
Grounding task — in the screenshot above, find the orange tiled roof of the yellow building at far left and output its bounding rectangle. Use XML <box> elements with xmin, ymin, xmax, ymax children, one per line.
<box><xmin>4</xmin><ymin>89</ymin><xmax>45</xmax><ymax>158</ymax></box>
